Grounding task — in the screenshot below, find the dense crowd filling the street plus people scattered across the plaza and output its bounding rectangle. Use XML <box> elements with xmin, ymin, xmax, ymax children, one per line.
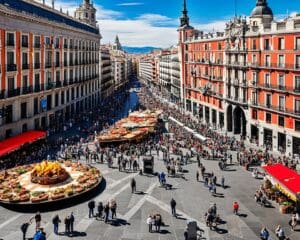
<box><xmin>0</xmin><ymin>77</ymin><xmax>297</xmax><ymax>239</ymax></box>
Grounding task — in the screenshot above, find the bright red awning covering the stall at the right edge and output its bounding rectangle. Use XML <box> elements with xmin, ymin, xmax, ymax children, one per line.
<box><xmin>263</xmin><ymin>164</ymin><xmax>300</xmax><ymax>195</ymax></box>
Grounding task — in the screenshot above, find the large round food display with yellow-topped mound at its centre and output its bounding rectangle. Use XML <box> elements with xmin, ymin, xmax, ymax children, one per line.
<box><xmin>0</xmin><ymin>161</ymin><xmax>101</xmax><ymax>204</ymax></box>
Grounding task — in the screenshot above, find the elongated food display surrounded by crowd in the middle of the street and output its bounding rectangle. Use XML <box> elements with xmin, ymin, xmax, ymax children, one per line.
<box><xmin>96</xmin><ymin>110</ymin><xmax>162</xmax><ymax>143</ymax></box>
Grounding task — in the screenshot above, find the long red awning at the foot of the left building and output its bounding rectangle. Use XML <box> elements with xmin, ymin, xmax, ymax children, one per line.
<box><xmin>0</xmin><ymin>131</ymin><xmax>46</xmax><ymax>157</ymax></box>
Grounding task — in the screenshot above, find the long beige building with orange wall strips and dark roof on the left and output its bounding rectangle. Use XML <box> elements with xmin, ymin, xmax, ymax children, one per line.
<box><xmin>0</xmin><ymin>0</ymin><xmax>101</xmax><ymax>139</ymax></box>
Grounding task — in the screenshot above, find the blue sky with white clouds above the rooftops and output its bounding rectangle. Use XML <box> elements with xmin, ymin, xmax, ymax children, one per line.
<box><xmin>36</xmin><ymin>0</ymin><xmax>300</xmax><ymax>48</ymax></box>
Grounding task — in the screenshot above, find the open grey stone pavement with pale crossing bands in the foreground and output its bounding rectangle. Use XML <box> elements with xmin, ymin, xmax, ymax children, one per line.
<box><xmin>0</xmin><ymin>149</ymin><xmax>300</xmax><ymax>240</ymax></box>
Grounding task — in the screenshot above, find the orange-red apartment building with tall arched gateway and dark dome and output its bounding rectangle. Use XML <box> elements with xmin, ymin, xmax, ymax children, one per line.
<box><xmin>178</xmin><ymin>0</ymin><xmax>300</xmax><ymax>154</ymax></box>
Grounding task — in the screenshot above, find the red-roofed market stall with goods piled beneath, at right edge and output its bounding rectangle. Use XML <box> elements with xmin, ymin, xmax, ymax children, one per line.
<box><xmin>263</xmin><ymin>164</ymin><xmax>300</xmax><ymax>212</ymax></box>
